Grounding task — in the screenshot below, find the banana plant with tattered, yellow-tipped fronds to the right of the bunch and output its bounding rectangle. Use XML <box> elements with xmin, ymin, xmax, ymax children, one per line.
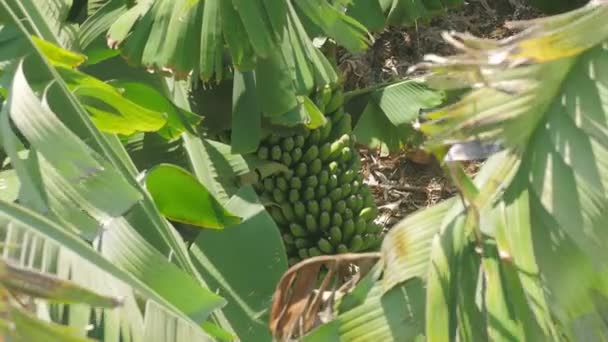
<box><xmin>282</xmin><ymin>1</ymin><xmax>608</xmax><ymax>341</ymax></box>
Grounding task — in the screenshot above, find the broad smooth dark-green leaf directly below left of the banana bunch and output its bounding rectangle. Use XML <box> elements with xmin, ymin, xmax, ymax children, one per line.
<box><xmin>190</xmin><ymin>187</ymin><xmax>287</xmax><ymax>341</ymax></box>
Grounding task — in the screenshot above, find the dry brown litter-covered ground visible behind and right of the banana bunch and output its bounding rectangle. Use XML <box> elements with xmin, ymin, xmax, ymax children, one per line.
<box><xmin>350</xmin><ymin>0</ymin><xmax>541</xmax><ymax>229</ymax></box>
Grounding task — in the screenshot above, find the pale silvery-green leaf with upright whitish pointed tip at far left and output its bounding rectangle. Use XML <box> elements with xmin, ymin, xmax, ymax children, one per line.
<box><xmin>8</xmin><ymin>58</ymin><xmax>141</xmax><ymax>222</ymax></box>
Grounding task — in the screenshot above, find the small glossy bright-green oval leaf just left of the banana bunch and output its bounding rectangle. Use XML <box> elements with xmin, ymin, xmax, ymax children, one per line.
<box><xmin>146</xmin><ymin>164</ymin><xmax>241</xmax><ymax>229</ymax></box>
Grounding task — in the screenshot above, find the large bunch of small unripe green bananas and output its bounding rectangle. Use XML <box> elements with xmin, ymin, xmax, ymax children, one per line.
<box><xmin>256</xmin><ymin>88</ymin><xmax>382</xmax><ymax>264</ymax></box>
